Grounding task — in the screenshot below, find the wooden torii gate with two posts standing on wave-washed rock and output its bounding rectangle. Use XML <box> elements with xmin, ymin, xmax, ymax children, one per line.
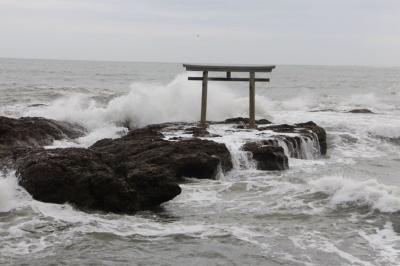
<box><xmin>183</xmin><ymin>64</ymin><xmax>275</xmax><ymax>128</ymax></box>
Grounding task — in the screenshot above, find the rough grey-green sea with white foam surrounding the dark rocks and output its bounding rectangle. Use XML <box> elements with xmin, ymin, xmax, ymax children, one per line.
<box><xmin>0</xmin><ymin>59</ymin><xmax>400</xmax><ymax>266</ymax></box>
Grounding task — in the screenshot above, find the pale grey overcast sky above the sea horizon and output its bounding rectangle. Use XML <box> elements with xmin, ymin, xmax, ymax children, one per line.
<box><xmin>0</xmin><ymin>0</ymin><xmax>400</xmax><ymax>66</ymax></box>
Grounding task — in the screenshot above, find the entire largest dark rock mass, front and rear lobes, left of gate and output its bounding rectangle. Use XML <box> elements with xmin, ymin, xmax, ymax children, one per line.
<box><xmin>16</xmin><ymin>125</ymin><xmax>232</xmax><ymax>213</ymax></box>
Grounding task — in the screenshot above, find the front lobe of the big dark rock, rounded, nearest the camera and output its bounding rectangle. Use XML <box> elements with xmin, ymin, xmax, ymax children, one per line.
<box><xmin>17</xmin><ymin>148</ymin><xmax>181</xmax><ymax>213</ymax></box>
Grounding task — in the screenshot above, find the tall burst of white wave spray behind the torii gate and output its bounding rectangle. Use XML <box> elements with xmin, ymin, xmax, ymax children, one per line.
<box><xmin>25</xmin><ymin>74</ymin><xmax>271</xmax><ymax>129</ymax></box>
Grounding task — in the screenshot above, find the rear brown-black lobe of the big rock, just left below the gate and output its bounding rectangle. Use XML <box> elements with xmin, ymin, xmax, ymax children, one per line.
<box><xmin>91</xmin><ymin>127</ymin><xmax>232</xmax><ymax>180</ymax></box>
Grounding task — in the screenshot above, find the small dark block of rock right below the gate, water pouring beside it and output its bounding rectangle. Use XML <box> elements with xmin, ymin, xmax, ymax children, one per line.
<box><xmin>242</xmin><ymin>142</ymin><xmax>289</xmax><ymax>170</ymax></box>
